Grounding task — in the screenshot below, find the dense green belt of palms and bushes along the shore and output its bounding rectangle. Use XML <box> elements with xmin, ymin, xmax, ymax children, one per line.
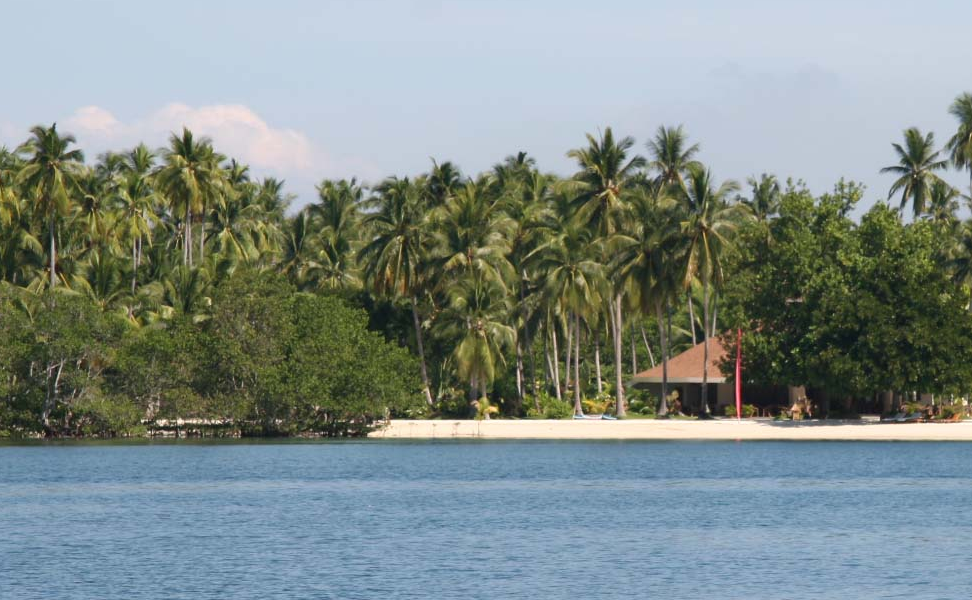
<box><xmin>0</xmin><ymin>94</ymin><xmax>972</xmax><ymax>434</ymax></box>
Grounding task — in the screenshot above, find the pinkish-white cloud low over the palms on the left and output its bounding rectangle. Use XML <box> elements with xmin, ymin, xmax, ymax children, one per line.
<box><xmin>61</xmin><ymin>103</ymin><xmax>380</xmax><ymax>206</ymax></box>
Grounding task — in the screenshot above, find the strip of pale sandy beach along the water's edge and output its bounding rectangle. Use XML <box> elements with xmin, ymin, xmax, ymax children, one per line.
<box><xmin>369</xmin><ymin>419</ymin><xmax>972</xmax><ymax>441</ymax></box>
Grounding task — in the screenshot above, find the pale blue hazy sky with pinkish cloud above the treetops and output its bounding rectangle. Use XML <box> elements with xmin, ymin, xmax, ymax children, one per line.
<box><xmin>0</xmin><ymin>0</ymin><xmax>972</xmax><ymax>209</ymax></box>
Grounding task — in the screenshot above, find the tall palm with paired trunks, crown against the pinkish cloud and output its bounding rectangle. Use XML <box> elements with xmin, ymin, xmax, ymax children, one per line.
<box><xmin>157</xmin><ymin>127</ymin><xmax>223</xmax><ymax>265</ymax></box>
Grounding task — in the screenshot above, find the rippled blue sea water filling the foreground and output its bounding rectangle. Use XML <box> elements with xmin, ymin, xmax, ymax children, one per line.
<box><xmin>0</xmin><ymin>441</ymin><xmax>972</xmax><ymax>600</ymax></box>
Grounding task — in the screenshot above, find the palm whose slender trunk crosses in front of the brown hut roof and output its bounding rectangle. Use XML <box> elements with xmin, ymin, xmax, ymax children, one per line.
<box><xmin>681</xmin><ymin>165</ymin><xmax>739</xmax><ymax>418</ymax></box>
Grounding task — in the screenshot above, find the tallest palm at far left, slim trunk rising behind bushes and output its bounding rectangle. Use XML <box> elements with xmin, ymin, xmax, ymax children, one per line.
<box><xmin>17</xmin><ymin>123</ymin><xmax>84</xmax><ymax>289</ymax></box>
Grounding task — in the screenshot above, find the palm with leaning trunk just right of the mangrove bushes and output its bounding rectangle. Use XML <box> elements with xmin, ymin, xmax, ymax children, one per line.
<box><xmin>358</xmin><ymin>177</ymin><xmax>432</xmax><ymax>406</ymax></box>
